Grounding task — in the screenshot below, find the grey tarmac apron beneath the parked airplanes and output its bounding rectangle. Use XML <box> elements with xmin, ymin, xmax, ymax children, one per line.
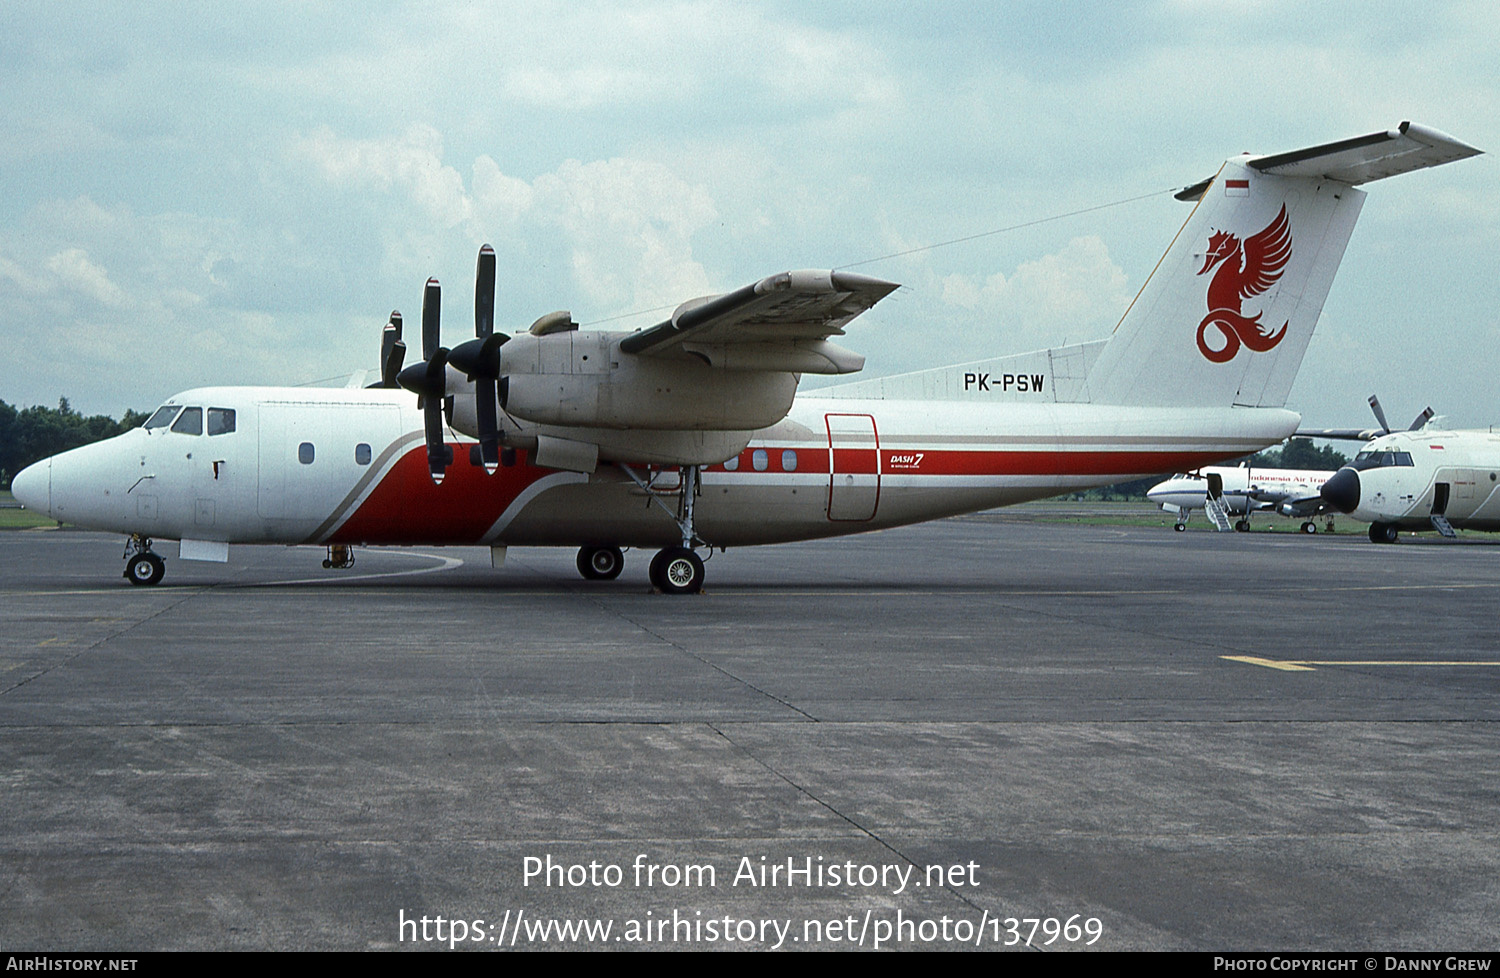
<box><xmin>0</xmin><ymin>513</ymin><xmax>1500</xmax><ymax>951</ymax></box>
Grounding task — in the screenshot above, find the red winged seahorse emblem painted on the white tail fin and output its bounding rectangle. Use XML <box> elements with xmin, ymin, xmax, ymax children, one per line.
<box><xmin>1199</xmin><ymin>204</ymin><xmax>1292</xmax><ymax>363</ymax></box>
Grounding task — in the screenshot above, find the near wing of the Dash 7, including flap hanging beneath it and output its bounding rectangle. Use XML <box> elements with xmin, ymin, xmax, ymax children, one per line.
<box><xmin>620</xmin><ymin>272</ymin><xmax>900</xmax><ymax>374</ymax></box>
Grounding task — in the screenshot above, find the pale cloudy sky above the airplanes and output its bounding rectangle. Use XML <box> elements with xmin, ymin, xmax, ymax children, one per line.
<box><xmin>0</xmin><ymin>0</ymin><xmax>1500</xmax><ymax>426</ymax></box>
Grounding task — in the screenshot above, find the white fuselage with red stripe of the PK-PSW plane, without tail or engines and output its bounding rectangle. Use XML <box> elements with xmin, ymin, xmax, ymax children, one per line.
<box><xmin>14</xmin><ymin>387</ymin><xmax>1298</xmax><ymax>548</ymax></box>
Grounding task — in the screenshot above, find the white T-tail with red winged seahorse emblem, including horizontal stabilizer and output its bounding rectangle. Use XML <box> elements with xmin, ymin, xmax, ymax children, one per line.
<box><xmin>1086</xmin><ymin>123</ymin><xmax>1481</xmax><ymax>408</ymax></box>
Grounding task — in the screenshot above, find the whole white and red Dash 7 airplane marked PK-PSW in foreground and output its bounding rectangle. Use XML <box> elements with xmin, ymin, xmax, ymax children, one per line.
<box><xmin>12</xmin><ymin>123</ymin><xmax>1479</xmax><ymax>594</ymax></box>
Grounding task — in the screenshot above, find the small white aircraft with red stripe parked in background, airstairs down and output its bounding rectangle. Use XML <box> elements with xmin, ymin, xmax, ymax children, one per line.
<box><xmin>1146</xmin><ymin>465</ymin><xmax>1334</xmax><ymax>533</ymax></box>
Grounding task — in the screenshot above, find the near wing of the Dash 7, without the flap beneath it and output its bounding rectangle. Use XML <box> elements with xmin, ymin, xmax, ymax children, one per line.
<box><xmin>620</xmin><ymin>270</ymin><xmax>900</xmax><ymax>363</ymax></box>
